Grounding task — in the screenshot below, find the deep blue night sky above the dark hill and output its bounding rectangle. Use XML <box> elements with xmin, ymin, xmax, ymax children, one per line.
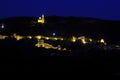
<box><xmin>0</xmin><ymin>0</ymin><xmax>120</xmax><ymax>20</ymax></box>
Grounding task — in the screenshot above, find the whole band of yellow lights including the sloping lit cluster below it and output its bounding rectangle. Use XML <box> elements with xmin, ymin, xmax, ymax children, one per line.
<box><xmin>0</xmin><ymin>33</ymin><xmax>111</xmax><ymax>51</ymax></box>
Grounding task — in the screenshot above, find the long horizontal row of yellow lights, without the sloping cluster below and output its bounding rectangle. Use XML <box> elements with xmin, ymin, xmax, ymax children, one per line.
<box><xmin>0</xmin><ymin>33</ymin><xmax>107</xmax><ymax>45</ymax></box>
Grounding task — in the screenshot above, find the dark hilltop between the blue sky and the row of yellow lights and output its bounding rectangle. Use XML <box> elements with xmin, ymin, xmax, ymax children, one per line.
<box><xmin>0</xmin><ymin>16</ymin><xmax>120</xmax><ymax>42</ymax></box>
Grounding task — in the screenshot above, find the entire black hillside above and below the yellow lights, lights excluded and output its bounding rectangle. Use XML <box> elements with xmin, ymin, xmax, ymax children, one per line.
<box><xmin>0</xmin><ymin>16</ymin><xmax>120</xmax><ymax>75</ymax></box>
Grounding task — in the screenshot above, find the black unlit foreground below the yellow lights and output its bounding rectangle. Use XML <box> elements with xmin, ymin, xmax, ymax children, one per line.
<box><xmin>0</xmin><ymin>40</ymin><xmax>120</xmax><ymax>76</ymax></box>
